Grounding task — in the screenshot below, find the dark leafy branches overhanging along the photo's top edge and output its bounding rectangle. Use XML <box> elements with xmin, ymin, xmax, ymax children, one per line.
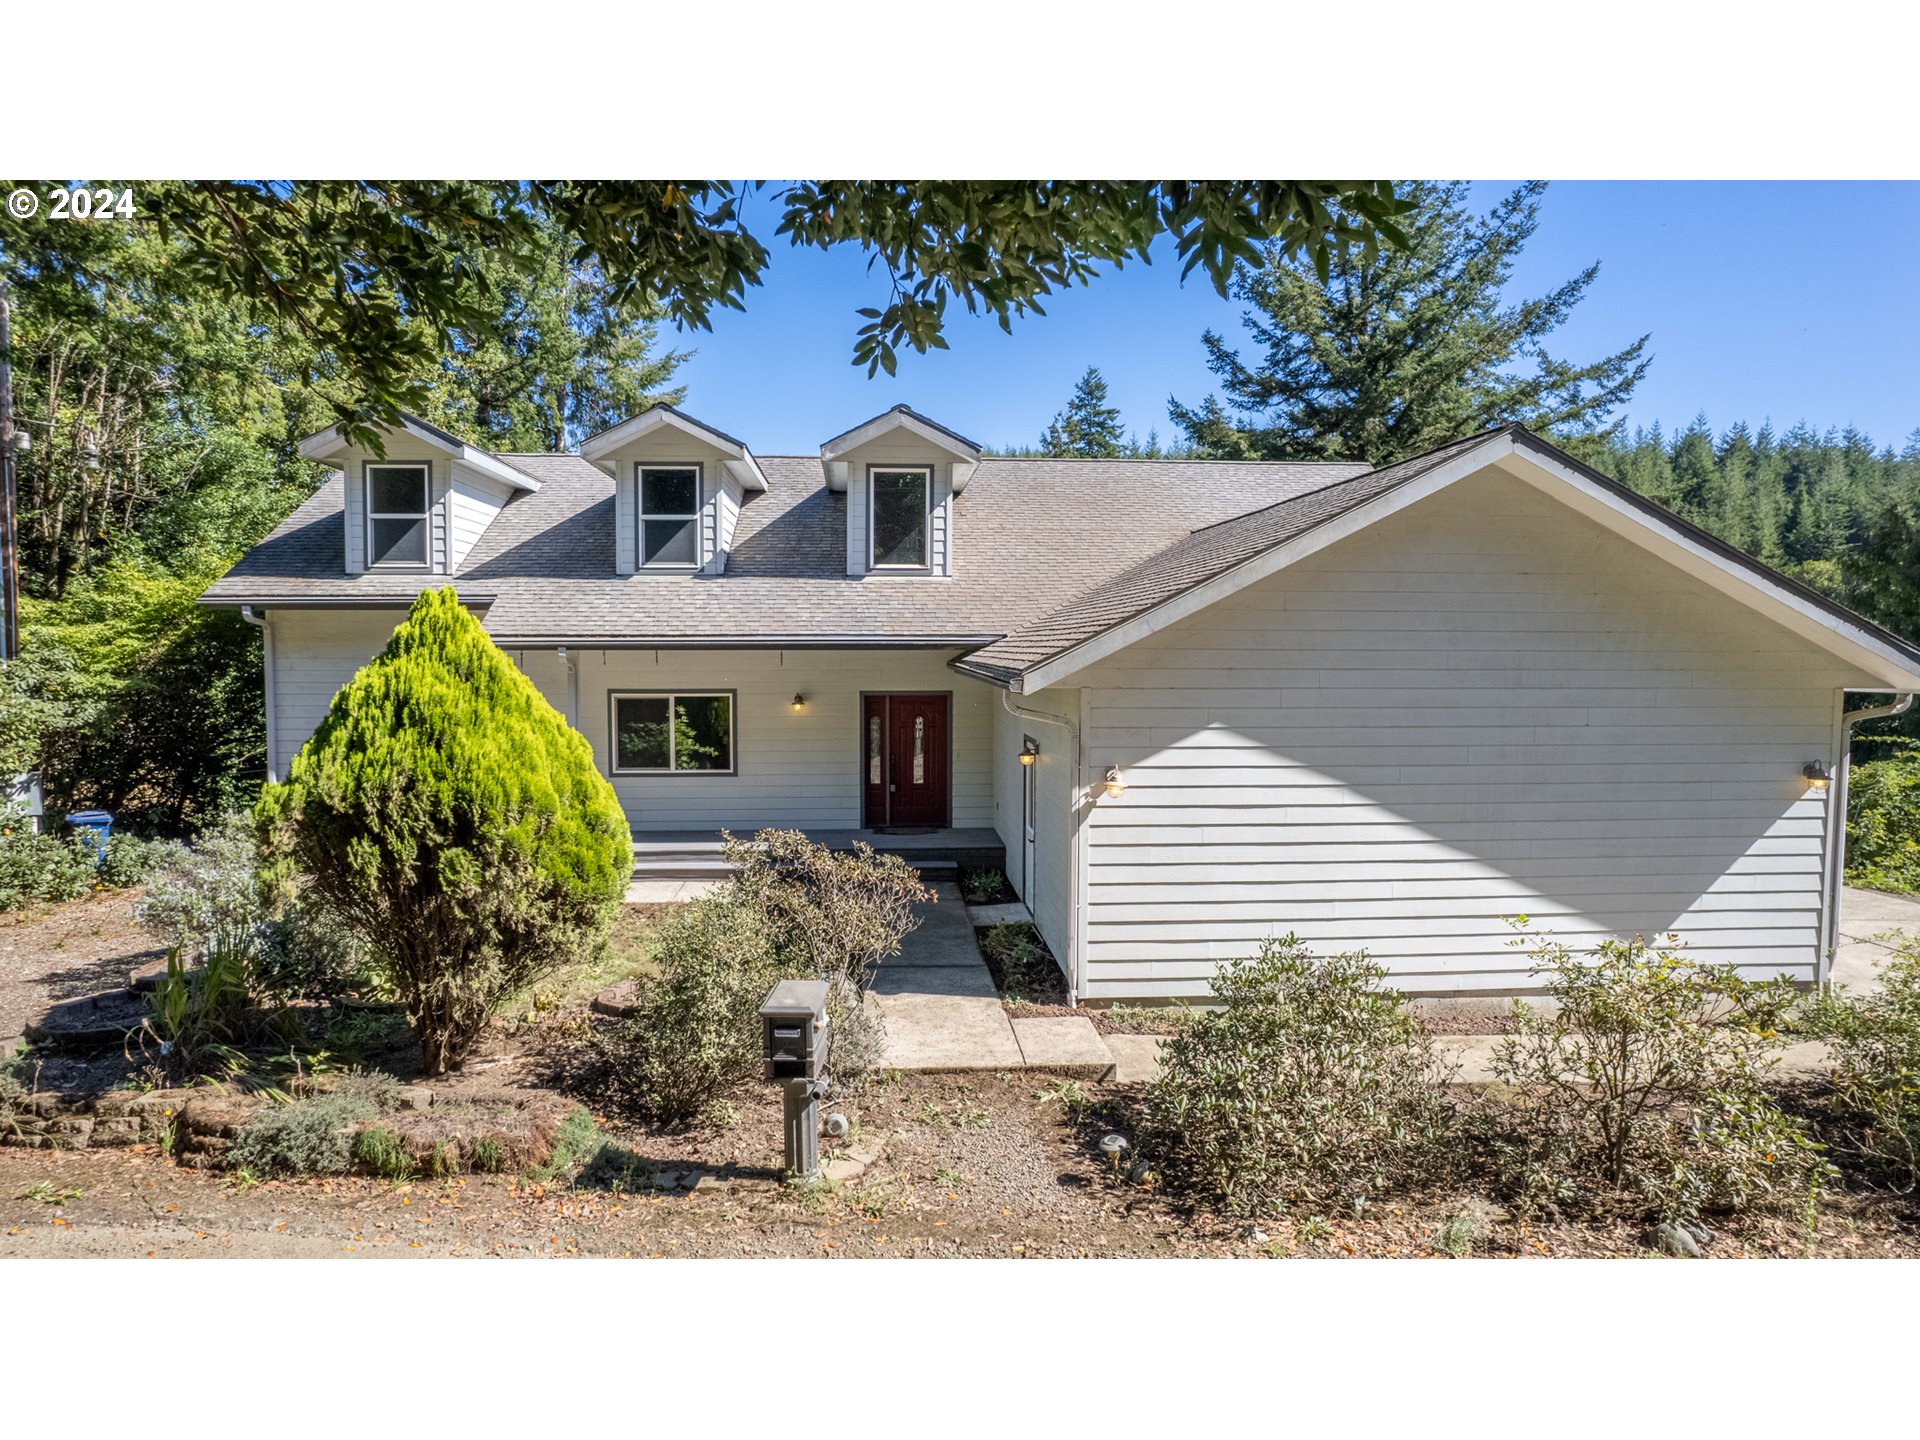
<box><xmin>0</xmin><ymin>180</ymin><xmax>1404</xmax><ymax>442</ymax></box>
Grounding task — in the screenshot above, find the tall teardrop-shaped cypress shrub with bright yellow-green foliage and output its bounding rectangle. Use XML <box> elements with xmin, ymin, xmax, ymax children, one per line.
<box><xmin>255</xmin><ymin>588</ymin><xmax>634</xmax><ymax>1075</ymax></box>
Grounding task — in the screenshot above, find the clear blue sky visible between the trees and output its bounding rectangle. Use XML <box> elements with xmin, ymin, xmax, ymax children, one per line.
<box><xmin>662</xmin><ymin>180</ymin><xmax>1920</xmax><ymax>455</ymax></box>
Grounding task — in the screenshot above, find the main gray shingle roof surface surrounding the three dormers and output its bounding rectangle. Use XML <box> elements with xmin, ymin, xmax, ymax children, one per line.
<box><xmin>202</xmin><ymin>455</ymin><xmax>1367</xmax><ymax>645</ymax></box>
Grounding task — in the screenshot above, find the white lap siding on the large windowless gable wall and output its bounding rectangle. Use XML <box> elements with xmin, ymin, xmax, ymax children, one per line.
<box><xmin>1077</xmin><ymin>474</ymin><xmax>1870</xmax><ymax>998</ymax></box>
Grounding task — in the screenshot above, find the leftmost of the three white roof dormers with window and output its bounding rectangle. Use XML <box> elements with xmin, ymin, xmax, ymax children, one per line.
<box><xmin>300</xmin><ymin>415</ymin><xmax>540</xmax><ymax>576</ymax></box>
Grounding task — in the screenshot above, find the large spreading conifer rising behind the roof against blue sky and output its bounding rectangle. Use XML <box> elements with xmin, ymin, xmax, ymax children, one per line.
<box><xmin>1169</xmin><ymin>182</ymin><xmax>1649</xmax><ymax>465</ymax></box>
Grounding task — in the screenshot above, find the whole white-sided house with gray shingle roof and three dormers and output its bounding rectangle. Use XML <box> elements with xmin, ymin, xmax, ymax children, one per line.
<box><xmin>202</xmin><ymin>405</ymin><xmax>1920</xmax><ymax>1002</ymax></box>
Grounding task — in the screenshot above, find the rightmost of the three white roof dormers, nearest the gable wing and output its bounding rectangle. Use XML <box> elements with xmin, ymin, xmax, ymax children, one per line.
<box><xmin>820</xmin><ymin>405</ymin><xmax>979</xmax><ymax>576</ymax></box>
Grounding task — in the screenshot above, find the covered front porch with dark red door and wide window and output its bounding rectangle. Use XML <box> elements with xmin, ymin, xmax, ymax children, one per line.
<box><xmin>507</xmin><ymin>645</ymin><xmax>1020</xmax><ymax>881</ymax></box>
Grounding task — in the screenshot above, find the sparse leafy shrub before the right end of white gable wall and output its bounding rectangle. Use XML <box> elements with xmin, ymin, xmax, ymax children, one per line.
<box><xmin>1494</xmin><ymin>922</ymin><xmax>1832</xmax><ymax>1221</ymax></box>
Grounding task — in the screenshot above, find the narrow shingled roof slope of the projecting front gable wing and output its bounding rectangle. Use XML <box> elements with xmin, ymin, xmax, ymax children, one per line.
<box><xmin>954</xmin><ymin>430</ymin><xmax>1505</xmax><ymax>684</ymax></box>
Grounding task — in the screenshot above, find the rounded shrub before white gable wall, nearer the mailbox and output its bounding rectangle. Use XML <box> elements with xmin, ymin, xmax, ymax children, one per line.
<box><xmin>1139</xmin><ymin>935</ymin><xmax>1453</xmax><ymax>1215</ymax></box>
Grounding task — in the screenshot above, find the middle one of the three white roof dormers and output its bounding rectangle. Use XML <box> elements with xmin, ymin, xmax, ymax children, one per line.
<box><xmin>580</xmin><ymin>405</ymin><xmax>766</xmax><ymax>574</ymax></box>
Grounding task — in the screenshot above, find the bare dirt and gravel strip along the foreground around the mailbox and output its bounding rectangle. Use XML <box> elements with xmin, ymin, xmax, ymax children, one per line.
<box><xmin>0</xmin><ymin>1075</ymin><xmax>1920</xmax><ymax>1260</ymax></box>
